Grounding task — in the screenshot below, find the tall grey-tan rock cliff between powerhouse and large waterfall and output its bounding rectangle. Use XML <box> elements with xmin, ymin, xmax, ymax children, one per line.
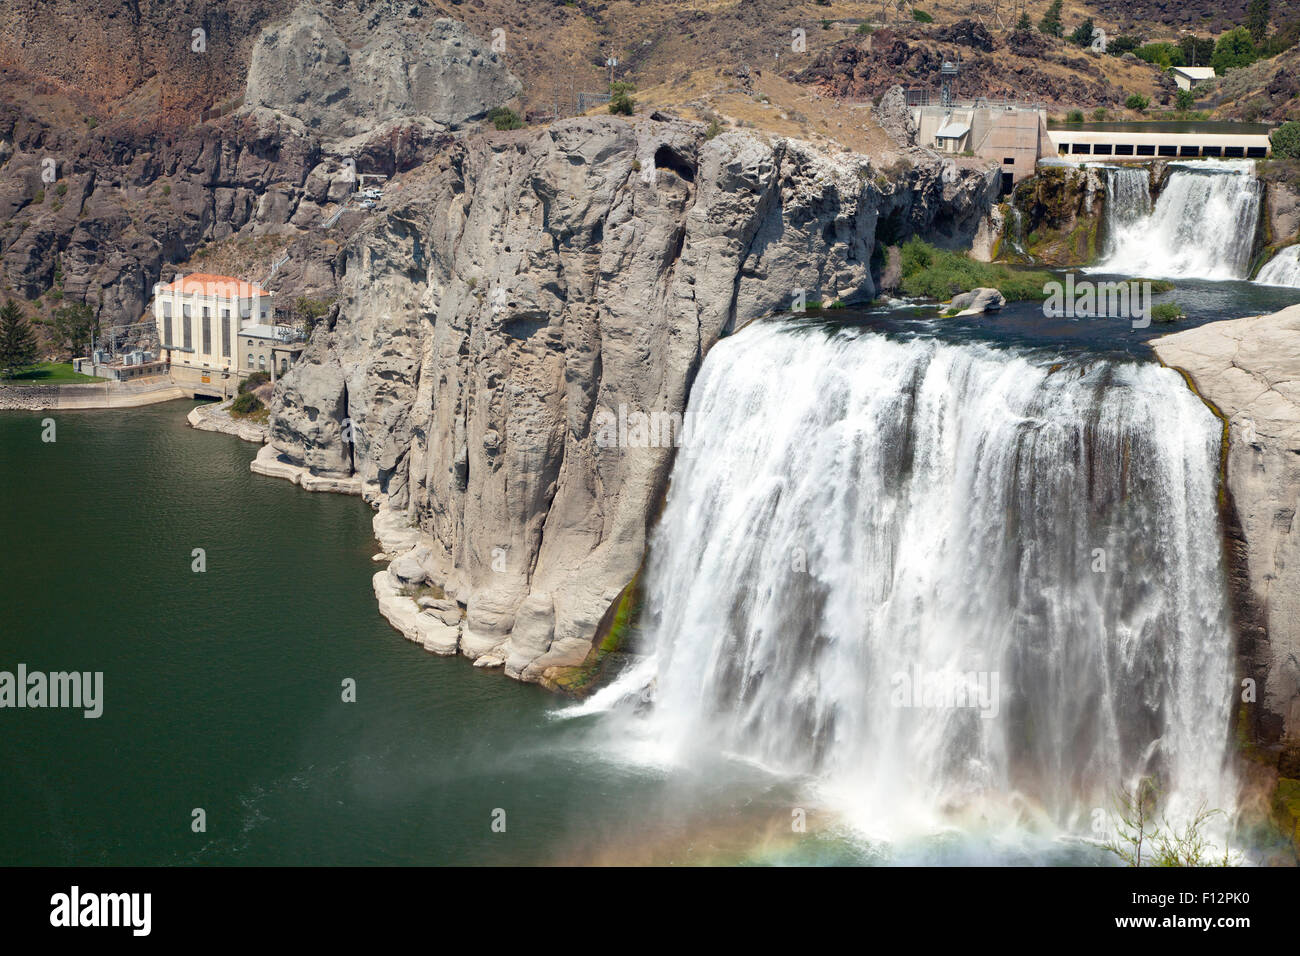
<box><xmin>272</xmin><ymin>118</ymin><xmax>996</xmax><ymax>680</ymax></box>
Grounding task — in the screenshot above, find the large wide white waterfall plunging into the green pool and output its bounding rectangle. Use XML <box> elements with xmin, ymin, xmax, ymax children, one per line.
<box><xmin>582</xmin><ymin>321</ymin><xmax>1234</xmax><ymax>853</ymax></box>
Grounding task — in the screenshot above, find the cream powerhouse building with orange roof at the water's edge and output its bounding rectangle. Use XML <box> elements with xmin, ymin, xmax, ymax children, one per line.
<box><xmin>153</xmin><ymin>273</ymin><xmax>303</xmax><ymax>384</ymax></box>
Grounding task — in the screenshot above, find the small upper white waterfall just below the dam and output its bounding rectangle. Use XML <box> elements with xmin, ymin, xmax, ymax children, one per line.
<box><xmin>1096</xmin><ymin>160</ymin><xmax>1260</xmax><ymax>278</ymax></box>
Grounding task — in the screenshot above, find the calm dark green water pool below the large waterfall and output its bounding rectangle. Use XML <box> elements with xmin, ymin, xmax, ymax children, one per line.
<box><xmin>0</xmin><ymin>402</ymin><xmax>872</xmax><ymax>865</ymax></box>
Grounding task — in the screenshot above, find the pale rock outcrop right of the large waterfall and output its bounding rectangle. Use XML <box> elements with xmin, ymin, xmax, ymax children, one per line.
<box><xmin>1153</xmin><ymin>306</ymin><xmax>1300</xmax><ymax>777</ymax></box>
